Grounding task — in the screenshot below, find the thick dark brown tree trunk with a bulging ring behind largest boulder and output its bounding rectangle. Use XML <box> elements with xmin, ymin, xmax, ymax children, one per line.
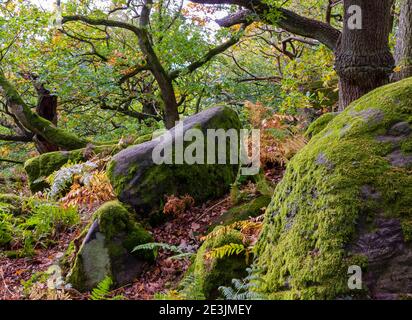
<box><xmin>335</xmin><ymin>0</ymin><xmax>394</xmax><ymax>110</ymax></box>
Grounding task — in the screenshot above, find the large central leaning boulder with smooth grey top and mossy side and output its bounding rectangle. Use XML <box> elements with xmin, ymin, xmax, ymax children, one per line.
<box><xmin>108</xmin><ymin>107</ymin><xmax>240</xmax><ymax>221</ymax></box>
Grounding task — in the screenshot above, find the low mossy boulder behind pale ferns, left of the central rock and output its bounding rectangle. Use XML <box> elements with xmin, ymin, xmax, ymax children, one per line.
<box><xmin>24</xmin><ymin>145</ymin><xmax>118</xmax><ymax>192</ymax></box>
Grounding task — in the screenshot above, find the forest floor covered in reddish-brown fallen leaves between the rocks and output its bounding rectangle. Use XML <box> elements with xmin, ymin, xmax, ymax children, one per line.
<box><xmin>0</xmin><ymin>169</ymin><xmax>283</xmax><ymax>300</ymax></box>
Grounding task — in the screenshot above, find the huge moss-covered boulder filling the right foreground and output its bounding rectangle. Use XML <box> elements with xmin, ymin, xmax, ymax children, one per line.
<box><xmin>256</xmin><ymin>79</ymin><xmax>412</xmax><ymax>299</ymax></box>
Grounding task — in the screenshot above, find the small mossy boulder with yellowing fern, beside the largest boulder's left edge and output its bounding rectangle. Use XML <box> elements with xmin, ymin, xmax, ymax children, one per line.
<box><xmin>182</xmin><ymin>226</ymin><xmax>247</xmax><ymax>299</ymax></box>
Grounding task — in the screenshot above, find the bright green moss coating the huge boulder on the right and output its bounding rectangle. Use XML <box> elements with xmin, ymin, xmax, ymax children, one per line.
<box><xmin>256</xmin><ymin>79</ymin><xmax>412</xmax><ymax>299</ymax></box>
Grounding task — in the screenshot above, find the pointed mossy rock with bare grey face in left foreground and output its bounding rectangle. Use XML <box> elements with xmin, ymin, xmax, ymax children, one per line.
<box><xmin>67</xmin><ymin>201</ymin><xmax>155</xmax><ymax>291</ymax></box>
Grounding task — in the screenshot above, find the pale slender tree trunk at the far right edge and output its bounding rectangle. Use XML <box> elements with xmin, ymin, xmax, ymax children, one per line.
<box><xmin>393</xmin><ymin>0</ymin><xmax>412</xmax><ymax>81</ymax></box>
